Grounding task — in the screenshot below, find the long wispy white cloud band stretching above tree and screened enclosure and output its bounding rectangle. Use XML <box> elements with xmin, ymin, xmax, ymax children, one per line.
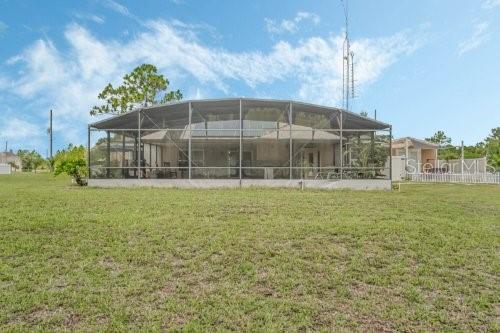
<box><xmin>3</xmin><ymin>21</ymin><xmax>418</xmax><ymax>148</ymax></box>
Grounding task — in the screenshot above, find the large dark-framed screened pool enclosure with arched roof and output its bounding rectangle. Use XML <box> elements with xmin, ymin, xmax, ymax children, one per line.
<box><xmin>88</xmin><ymin>98</ymin><xmax>391</xmax><ymax>185</ymax></box>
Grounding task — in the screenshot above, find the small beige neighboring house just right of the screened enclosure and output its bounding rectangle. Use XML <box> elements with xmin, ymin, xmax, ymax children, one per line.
<box><xmin>392</xmin><ymin>137</ymin><xmax>439</xmax><ymax>173</ymax></box>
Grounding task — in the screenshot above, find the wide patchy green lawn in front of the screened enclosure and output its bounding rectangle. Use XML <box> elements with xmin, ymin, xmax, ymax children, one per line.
<box><xmin>0</xmin><ymin>174</ymin><xmax>500</xmax><ymax>332</ymax></box>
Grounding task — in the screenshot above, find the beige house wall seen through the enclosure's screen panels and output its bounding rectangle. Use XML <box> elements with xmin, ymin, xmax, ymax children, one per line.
<box><xmin>110</xmin><ymin>140</ymin><xmax>341</xmax><ymax>178</ymax></box>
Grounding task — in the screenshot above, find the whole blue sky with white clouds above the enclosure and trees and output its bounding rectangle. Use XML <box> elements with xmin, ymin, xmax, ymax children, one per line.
<box><xmin>0</xmin><ymin>0</ymin><xmax>500</xmax><ymax>155</ymax></box>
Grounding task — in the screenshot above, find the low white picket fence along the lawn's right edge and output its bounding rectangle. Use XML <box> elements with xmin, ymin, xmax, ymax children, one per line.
<box><xmin>407</xmin><ymin>173</ymin><xmax>500</xmax><ymax>184</ymax></box>
